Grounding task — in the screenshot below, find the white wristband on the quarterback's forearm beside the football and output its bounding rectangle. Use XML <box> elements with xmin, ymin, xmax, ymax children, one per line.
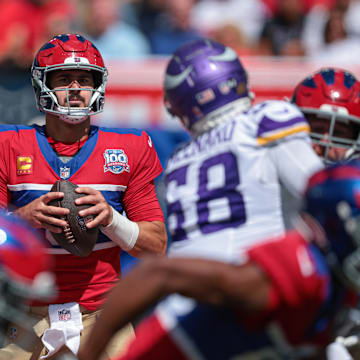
<box><xmin>100</xmin><ymin>207</ymin><xmax>139</xmax><ymax>251</ymax></box>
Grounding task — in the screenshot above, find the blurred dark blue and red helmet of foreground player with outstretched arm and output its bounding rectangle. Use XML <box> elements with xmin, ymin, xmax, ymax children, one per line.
<box><xmin>304</xmin><ymin>159</ymin><xmax>360</xmax><ymax>291</ymax></box>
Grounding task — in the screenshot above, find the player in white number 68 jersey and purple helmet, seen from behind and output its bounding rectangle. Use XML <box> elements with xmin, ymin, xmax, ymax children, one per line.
<box><xmin>164</xmin><ymin>39</ymin><xmax>323</xmax><ymax>258</ymax></box>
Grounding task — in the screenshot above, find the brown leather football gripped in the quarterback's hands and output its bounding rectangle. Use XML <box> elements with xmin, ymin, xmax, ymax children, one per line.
<box><xmin>49</xmin><ymin>180</ymin><xmax>99</xmax><ymax>257</ymax></box>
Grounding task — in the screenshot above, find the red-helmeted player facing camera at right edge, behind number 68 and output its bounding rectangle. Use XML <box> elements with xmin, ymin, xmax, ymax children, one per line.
<box><xmin>291</xmin><ymin>68</ymin><xmax>360</xmax><ymax>360</ymax></box>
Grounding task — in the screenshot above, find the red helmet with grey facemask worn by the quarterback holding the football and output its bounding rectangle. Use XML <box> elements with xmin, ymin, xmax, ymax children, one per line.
<box><xmin>31</xmin><ymin>34</ymin><xmax>108</xmax><ymax>124</ymax></box>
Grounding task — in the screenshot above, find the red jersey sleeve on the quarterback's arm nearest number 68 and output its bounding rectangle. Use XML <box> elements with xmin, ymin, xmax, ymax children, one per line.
<box><xmin>124</xmin><ymin>131</ymin><xmax>165</xmax><ymax>221</ymax></box>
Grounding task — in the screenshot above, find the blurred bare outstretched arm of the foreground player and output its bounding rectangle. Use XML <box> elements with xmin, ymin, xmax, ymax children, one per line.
<box><xmin>79</xmin><ymin>257</ymin><xmax>270</xmax><ymax>360</ymax></box>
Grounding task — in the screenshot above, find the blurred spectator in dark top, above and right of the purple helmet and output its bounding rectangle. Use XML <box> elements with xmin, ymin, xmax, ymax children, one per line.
<box><xmin>258</xmin><ymin>0</ymin><xmax>305</xmax><ymax>56</ymax></box>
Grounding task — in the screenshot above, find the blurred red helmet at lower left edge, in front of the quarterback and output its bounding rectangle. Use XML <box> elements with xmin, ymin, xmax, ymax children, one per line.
<box><xmin>0</xmin><ymin>212</ymin><xmax>55</xmax><ymax>345</ymax></box>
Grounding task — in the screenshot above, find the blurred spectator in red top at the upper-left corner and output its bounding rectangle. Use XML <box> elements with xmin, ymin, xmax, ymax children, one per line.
<box><xmin>0</xmin><ymin>0</ymin><xmax>74</xmax><ymax>124</ymax></box>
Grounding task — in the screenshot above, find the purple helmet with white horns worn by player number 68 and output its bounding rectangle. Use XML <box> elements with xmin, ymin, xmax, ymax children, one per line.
<box><xmin>164</xmin><ymin>39</ymin><xmax>252</xmax><ymax>134</ymax></box>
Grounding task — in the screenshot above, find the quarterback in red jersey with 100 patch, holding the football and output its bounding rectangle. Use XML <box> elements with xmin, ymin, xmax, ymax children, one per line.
<box><xmin>0</xmin><ymin>34</ymin><xmax>167</xmax><ymax>359</ymax></box>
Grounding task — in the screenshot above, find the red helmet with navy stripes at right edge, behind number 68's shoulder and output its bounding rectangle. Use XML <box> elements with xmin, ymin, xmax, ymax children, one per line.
<box><xmin>291</xmin><ymin>68</ymin><xmax>360</xmax><ymax>160</ymax></box>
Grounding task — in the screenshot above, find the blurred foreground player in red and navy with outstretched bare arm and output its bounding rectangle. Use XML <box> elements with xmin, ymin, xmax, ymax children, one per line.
<box><xmin>79</xmin><ymin>160</ymin><xmax>360</xmax><ymax>360</ymax></box>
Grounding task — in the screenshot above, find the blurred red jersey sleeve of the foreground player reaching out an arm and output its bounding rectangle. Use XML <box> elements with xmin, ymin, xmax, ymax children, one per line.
<box><xmin>245</xmin><ymin>231</ymin><xmax>330</xmax><ymax>344</ymax></box>
